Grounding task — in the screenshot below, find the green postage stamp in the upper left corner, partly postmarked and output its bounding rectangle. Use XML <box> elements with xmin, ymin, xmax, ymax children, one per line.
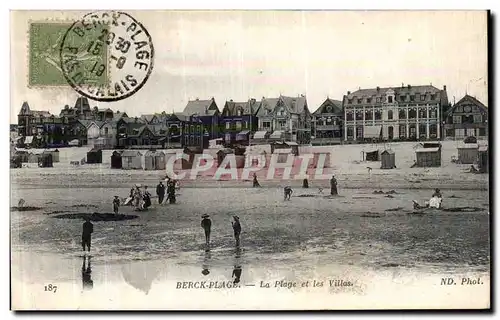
<box><xmin>28</xmin><ymin>21</ymin><xmax>108</xmax><ymax>87</ymax></box>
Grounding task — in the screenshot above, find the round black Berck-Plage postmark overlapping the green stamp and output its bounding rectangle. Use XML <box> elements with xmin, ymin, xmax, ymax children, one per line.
<box><xmin>60</xmin><ymin>11</ymin><xmax>154</xmax><ymax>101</ymax></box>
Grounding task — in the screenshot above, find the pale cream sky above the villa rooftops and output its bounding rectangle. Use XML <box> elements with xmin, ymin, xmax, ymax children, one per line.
<box><xmin>10</xmin><ymin>11</ymin><xmax>488</xmax><ymax>123</ymax></box>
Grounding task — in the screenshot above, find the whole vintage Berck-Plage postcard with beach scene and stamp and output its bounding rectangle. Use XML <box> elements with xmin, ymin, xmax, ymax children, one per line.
<box><xmin>9</xmin><ymin>9</ymin><xmax>495</xmax><ymax>311</ymax></box>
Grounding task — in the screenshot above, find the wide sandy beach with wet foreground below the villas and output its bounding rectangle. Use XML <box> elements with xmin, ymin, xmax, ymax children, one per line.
<box><xmin>11</xmin><ymin>141</ymin><xmax>490</xmax><ymax>310</ymax></box>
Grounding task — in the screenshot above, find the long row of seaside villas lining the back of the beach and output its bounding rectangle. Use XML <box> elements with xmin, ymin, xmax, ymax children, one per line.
<box><xmin>11</xmin><ymin>85</ymin><xmax>488</xmax><ymax>149</ymax></box>
